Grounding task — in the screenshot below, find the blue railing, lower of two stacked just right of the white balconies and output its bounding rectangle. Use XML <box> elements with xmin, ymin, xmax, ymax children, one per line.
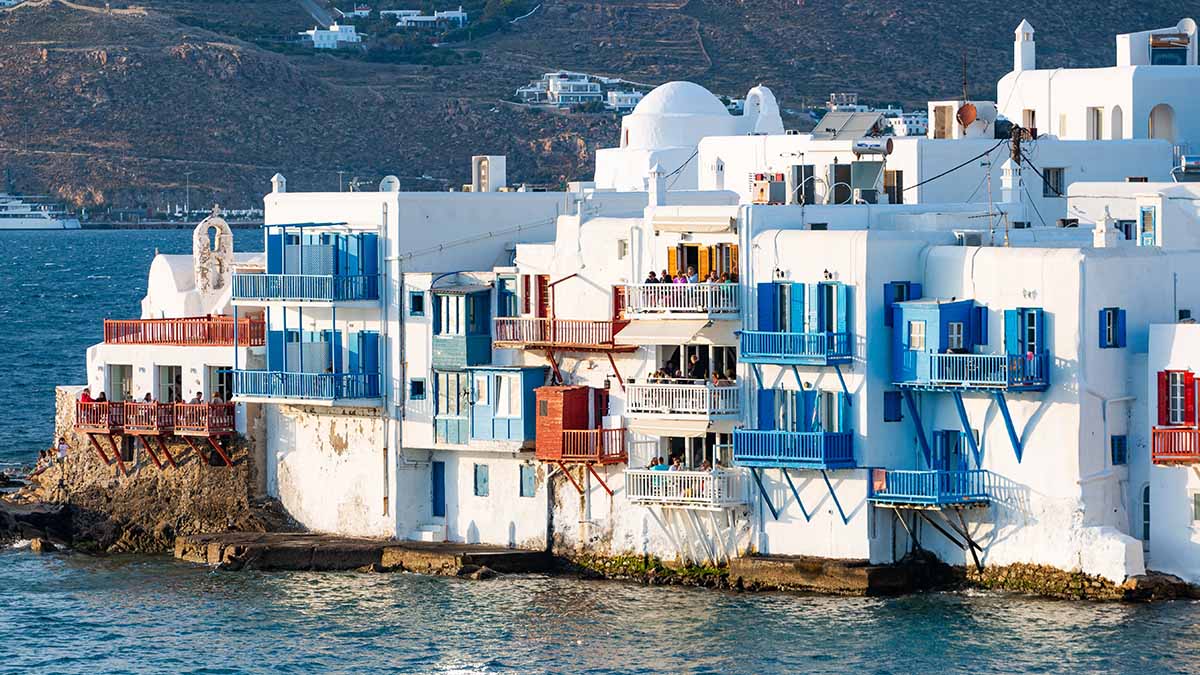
<box><xmin>733</xmin><ymin>429</ymin><xmax>854</xmax><ymax>468</ymax></box>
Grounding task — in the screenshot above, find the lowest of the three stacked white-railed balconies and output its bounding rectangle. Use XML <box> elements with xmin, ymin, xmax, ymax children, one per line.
<box><xmin>625</xmin><ymin>468</ymin><xmax>746</xmax><ymax>510</ymax></box>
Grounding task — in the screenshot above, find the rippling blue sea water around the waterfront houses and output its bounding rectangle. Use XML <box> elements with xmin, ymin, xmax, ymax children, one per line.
<box><xmin>0</xmin><ymin>231</ymin><xmax>1200</xmax><ymax>675</ymax></box>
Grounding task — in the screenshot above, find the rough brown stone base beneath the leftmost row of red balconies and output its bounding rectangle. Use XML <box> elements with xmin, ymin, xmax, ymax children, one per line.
<box><xmin>20</xmin><ymin>387</ymin><xmax>295</xmax><ymax>552</ymax></box>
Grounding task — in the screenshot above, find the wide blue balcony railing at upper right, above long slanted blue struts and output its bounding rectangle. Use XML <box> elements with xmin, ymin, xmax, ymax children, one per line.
<box><xmin>896</xmin><ymin>352</ymin><xmax>1050</xmax><ymax>392</ymax></box>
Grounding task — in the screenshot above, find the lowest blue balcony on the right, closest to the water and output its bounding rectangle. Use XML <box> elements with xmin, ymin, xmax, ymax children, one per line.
<box><xmin>868</xmin><ymin>468</ymin><xmax>995</xmax><ymax>508</ymax></box>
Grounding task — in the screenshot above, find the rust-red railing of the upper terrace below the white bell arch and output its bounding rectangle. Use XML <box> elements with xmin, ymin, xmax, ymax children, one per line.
<box><xmin>104</xmin><ymin>316</ymin><xmax>266</xmax><ymax>347</ymax></box>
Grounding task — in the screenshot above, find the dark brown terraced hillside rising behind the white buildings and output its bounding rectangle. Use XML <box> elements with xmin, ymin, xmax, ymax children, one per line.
<box><xmin>0</xmin><ymin>0</ymin><xmax>1181</xmax><ymax>207</ymax></box>
